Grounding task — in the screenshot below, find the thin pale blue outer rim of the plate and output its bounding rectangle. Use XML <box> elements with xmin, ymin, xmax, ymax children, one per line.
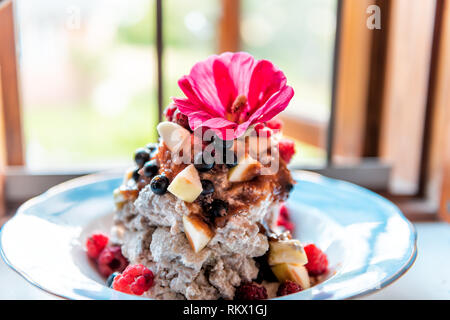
<box><xmin>0</xmin><ymin>171</ymin><xmax>417</xmax><ymax>300</ymax></box>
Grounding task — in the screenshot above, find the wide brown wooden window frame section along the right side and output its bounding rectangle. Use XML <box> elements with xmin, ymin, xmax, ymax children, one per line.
<box><xmin>333</xmin><ymin>0</ymin><xmax>450</xmax><ymax>221</ymax></box>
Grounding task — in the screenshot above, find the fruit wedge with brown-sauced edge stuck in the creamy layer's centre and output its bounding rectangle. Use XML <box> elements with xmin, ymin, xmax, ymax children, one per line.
<box><xmin>183</xmin><ymin>216</ymin><xmax>214</xmax><ymax>253</ymax></box>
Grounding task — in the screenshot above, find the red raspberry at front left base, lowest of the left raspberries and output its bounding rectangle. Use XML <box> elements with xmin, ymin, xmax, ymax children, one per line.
<box><xmin>113</xmin><ymin>264</ymin><xmax>154</xmax><ymax>296</ymax></box>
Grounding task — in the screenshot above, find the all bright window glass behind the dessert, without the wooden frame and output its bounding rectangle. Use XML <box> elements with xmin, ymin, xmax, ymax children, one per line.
<box><xmin>16</xmin><ymin>0</ymin><xmax>336</xmax><ymax>169</ymax></box>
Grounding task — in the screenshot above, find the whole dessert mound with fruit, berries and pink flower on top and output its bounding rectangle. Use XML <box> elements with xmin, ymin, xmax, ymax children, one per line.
<box><xmin>86</xmin><ymin>52</ymin><xmax>328</xmax><ymax>300</ymax></box>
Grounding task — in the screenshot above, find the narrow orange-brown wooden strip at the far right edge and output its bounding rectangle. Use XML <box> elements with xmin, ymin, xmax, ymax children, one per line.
<box><xmin>420</xmin><ymin>0</ymin><xmax>450</xmax><ymax>222</ymax></box>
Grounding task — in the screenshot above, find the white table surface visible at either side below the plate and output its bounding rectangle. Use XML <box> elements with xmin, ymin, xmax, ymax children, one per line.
<box><xmin>0</xmin><ymin>223</ymin><xmax>450</xmax><ymax>299</ymax></box>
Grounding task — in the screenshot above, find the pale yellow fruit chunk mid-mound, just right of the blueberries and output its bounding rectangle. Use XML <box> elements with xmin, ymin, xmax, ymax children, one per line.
<box><xmin>167</xmin><ymin>164</ymin><xmax>203</xmax><ymax>202</ymax></box>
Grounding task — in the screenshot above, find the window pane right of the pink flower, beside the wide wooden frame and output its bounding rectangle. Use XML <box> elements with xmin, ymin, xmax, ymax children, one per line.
<box><xmin>241</xmin><ymin>0</ymin><xmax>337</xmax><ymax>164</ymax></box>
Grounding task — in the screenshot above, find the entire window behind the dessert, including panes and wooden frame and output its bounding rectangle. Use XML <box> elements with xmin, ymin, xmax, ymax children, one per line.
<box><xmin>0</xmin><ymin>0</ymin><xmax>450</xmax><ymax>219</ymax></box>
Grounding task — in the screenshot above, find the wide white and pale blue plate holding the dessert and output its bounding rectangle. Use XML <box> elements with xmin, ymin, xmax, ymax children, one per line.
<box><xmin>0</xmin><ymin>172</ymin><xmax>417</xmax><ymax>299</ymax></box>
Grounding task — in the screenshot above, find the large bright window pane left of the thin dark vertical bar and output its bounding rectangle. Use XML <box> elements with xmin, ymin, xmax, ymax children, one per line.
<box><xmin>16</xmin><ymin>0</ymin><xmax>157</xmax><ymax>168</ymax></box>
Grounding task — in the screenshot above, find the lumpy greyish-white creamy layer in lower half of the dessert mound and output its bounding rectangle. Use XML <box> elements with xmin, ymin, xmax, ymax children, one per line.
<box><xmin>113</xmin><ymin>182</ymin><xmax>279</xmax><ymax>300</ymax></box>
